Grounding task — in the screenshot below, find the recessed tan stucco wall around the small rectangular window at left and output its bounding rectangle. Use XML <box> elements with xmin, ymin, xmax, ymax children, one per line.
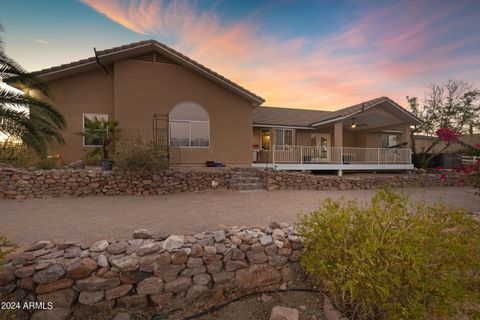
<box><xmin>43</xmin><ymin>68</ymin><xmax>113</xmax><ymax>162</ymax></box>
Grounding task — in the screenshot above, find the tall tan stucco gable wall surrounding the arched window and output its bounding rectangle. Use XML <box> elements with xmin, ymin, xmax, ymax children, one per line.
<box><xmin>114</xmin><ymin>60</ymin><xmax>253</xmax><ymax>165</ymax></box>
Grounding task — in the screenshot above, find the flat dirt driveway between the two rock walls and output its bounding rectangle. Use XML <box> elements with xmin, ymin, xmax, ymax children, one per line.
<box><xmin>0</xmin><ymin>187</ymin><xmax>480</xmax><ymax>243</ymax></box>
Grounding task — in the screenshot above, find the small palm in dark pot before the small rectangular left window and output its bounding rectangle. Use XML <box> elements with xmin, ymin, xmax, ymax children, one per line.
<box><xmin>83</xmin><ymin>117</ymin><xmax>118</xmax><ymax>170</ymax></box>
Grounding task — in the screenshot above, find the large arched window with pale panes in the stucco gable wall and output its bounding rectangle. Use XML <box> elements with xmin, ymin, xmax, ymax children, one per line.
<box><xmin>169</xmin><ymin>102</ymin><xmax>210</xmax><ymax>147</ymax></box>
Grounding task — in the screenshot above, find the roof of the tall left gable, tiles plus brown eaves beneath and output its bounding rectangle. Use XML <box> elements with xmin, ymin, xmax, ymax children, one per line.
<box><xmin>28</xmin><ymin>40</ymin><xmax>265</xmax><ymax>106</ymax></box>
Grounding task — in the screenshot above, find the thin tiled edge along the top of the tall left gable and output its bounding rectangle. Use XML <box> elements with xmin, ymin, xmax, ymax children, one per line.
<box><xmin>33</xmin><ymin>40</ymin><xmax>265</xmax><ymax>104</ymax></box>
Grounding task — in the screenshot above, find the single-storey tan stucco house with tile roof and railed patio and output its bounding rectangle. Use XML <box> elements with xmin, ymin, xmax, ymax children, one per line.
<box><xmin>12</xmin><ymin>40</ymin><xmax>420</xmax><ymax>173</ymax></box>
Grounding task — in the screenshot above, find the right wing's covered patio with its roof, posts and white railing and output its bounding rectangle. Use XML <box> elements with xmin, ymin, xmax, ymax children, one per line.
<box><xmin>252</xmin><ymin>98</ymin><xmax>419</xmax><ymax>175</ymax></box>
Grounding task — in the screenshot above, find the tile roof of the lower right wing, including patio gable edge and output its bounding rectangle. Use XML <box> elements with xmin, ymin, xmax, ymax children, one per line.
<box><xmin>253</xmin><ymin>97</ymin><xmax>421</xmax><ymax>128</ymax></box>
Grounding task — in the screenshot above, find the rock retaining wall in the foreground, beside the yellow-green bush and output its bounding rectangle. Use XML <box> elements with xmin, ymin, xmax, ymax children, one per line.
<box><xmin>0</xmin><ymin>223</ymin><xmax>305</xmax><ymax>320</ymax></box>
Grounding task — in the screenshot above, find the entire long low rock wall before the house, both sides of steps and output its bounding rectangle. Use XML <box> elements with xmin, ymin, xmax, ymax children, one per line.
<box><xmin>0</xmin><ymin>166</ymin><xmax>471</xmax><ymax>199</ymax></box>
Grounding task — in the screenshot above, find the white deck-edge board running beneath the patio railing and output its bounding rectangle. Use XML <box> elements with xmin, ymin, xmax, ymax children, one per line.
<box><xmin>252</xmin><ymin>163</ymin><xmax>414</xmax><ymax>171</ymax></box>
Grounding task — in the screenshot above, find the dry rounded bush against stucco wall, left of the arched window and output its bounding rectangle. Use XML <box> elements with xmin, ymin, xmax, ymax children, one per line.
<box><xmin>115</xmin><ymin>137</ymin><xmax>168</xmax><ymax>174</ymax></box>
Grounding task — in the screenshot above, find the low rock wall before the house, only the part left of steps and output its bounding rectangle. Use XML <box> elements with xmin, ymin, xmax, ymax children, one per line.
<box><xmin>0</xmin><ymin>167</ymin><xmax>232</xmax><ymax>199</ymax></box>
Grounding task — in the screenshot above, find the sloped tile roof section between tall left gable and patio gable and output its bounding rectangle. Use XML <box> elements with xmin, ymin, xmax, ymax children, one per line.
<box><xmin>253</xmin><ymin>107</ymin><xmax>330</xmax><ymax>128</ymax></box>
